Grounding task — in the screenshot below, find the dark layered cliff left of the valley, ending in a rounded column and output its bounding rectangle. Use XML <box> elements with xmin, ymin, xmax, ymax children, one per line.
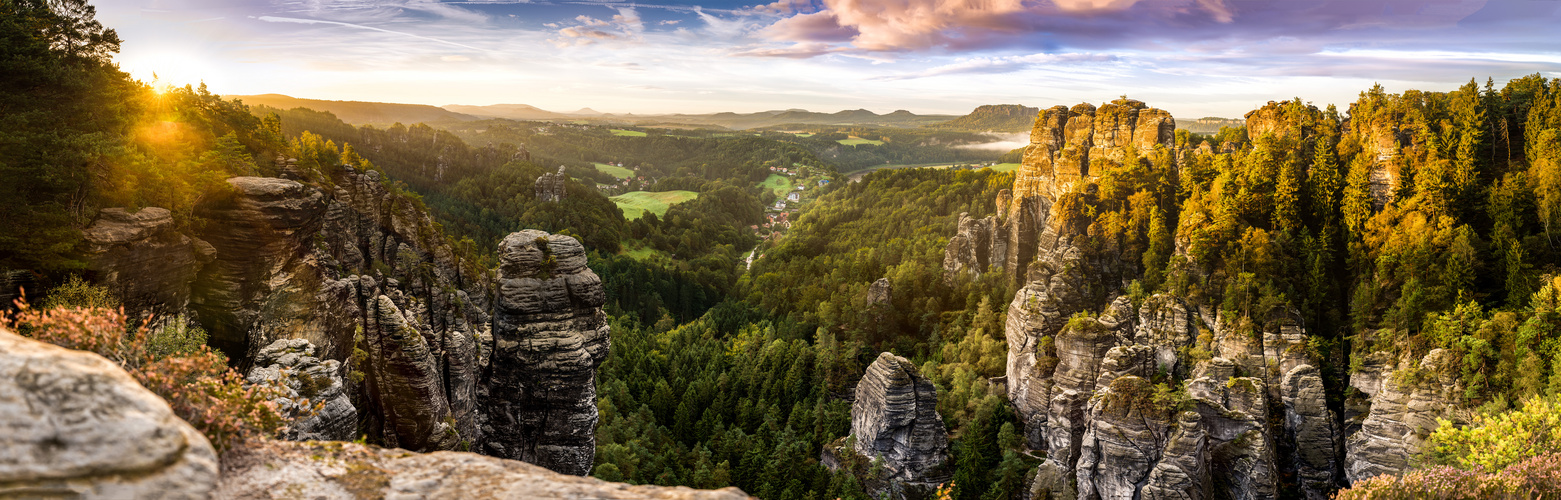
<box><xmin>77</xmin><ymin>166</ymin><xmax>609</xmax><ymax>473</ymax></box>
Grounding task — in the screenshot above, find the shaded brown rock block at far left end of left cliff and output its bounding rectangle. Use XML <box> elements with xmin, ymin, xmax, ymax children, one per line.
<box><xmin>81</xmin><ymin>206</ymin><xmax>215</xmax><ymax>316</ymax></box>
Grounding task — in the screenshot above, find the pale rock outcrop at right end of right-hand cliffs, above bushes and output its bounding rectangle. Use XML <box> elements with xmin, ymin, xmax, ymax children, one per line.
<box><xmin>1344</xmin><ymin>348</ymin><xmax>1460</xmax><ymax>483</ymax></box>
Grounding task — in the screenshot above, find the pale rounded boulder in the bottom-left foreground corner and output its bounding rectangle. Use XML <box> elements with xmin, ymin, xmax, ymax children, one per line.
<box><xmin>0</xmin><ymin>330</ymin><xmax>219</xmax><ymax>500</ymax></box>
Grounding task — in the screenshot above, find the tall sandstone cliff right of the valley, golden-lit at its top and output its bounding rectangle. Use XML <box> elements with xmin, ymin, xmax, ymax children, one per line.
<box><xmin>986</xmin><ymin>102</ymin><xmax>1392</xmax><ymax>498</ymax></box>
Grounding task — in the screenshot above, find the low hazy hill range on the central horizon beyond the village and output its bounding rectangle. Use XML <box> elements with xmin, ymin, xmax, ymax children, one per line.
<box><xmin>445</xmin><ymin>105</ymin><xmax>954</xmax><ymax>130</ymax></box>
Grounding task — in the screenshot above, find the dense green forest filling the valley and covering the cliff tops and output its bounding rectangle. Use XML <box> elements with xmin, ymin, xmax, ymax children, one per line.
<box><xmin>9</xmin><ymin>0</ymin><xmax>1561</xmax><ymax>500</ymax></box>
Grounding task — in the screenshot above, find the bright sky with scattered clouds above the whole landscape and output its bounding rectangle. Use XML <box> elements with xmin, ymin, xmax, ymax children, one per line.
<box><xmin>94</xmin><ymin>0</ymin><xmax>1561</xmax><ymax>119</ymax></box>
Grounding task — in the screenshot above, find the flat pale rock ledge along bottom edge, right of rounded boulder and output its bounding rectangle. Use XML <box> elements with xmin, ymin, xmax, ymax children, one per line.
<box><xmin>214</xmin><ymin>441</ymin><xmax>751</xmax><ymax>500</ymax></box>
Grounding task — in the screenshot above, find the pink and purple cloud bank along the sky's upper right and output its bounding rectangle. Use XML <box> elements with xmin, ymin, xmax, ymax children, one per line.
<box><xmin>752</xmin><ymin>0</ymin><xmax>1529</xmax><ymax>52</ymax></box>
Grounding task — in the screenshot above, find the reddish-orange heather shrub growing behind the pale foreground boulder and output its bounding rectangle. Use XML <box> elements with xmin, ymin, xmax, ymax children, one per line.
<box><xmin>0</xmin><ymin>302</ymin><xmax>286</xmax><ymax>452</ymax></box>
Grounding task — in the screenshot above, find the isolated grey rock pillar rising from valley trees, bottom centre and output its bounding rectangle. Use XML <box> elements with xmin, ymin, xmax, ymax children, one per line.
<box><xmin>851</xmin><ymin>352</ymin><xmax>949</xmax><ymax>498</ymax></box>
